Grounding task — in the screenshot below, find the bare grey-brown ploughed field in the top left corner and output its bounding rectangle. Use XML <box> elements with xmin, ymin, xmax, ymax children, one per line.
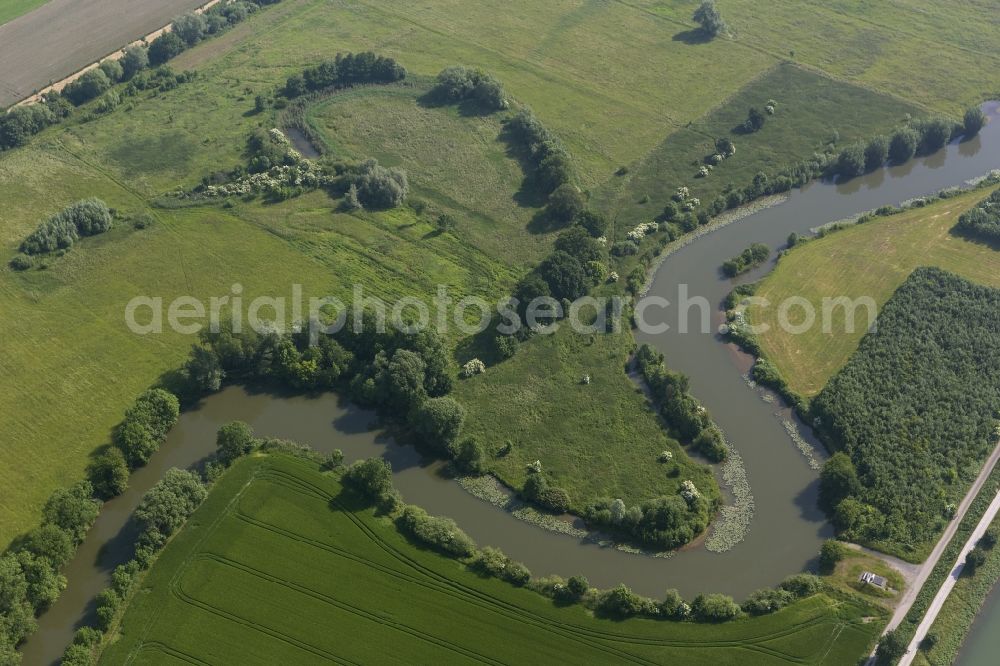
<box><xmin>0</xmin><ymin>0</ymin><xmax>205</xmax><ymax>107</ymax></box>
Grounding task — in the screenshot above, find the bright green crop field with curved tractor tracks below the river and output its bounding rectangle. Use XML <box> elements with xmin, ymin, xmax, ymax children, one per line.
<box><xmin>101</xmin><ymin>456</ymin><xmax>881</xmax><ymax>665</ymax></box>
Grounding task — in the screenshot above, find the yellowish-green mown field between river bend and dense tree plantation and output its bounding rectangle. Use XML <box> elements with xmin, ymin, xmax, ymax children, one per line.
<box><xmin>748</xmin><ymin>184</ymin><xmax>1000</xmax><ymax>398</ymax></box>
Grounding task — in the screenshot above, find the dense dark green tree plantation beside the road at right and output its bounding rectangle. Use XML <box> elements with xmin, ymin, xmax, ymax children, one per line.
<box><xmin>812</xmin><ymin>269</ymin><xmax>1000</xmax><ymax>548</ymax></box>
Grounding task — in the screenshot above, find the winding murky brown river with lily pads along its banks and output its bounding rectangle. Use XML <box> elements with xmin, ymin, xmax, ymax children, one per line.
<box><xmin>22</xmin><ymin>103</ymin><xmax>1000</xmax><ymax>665</ymax></box>
